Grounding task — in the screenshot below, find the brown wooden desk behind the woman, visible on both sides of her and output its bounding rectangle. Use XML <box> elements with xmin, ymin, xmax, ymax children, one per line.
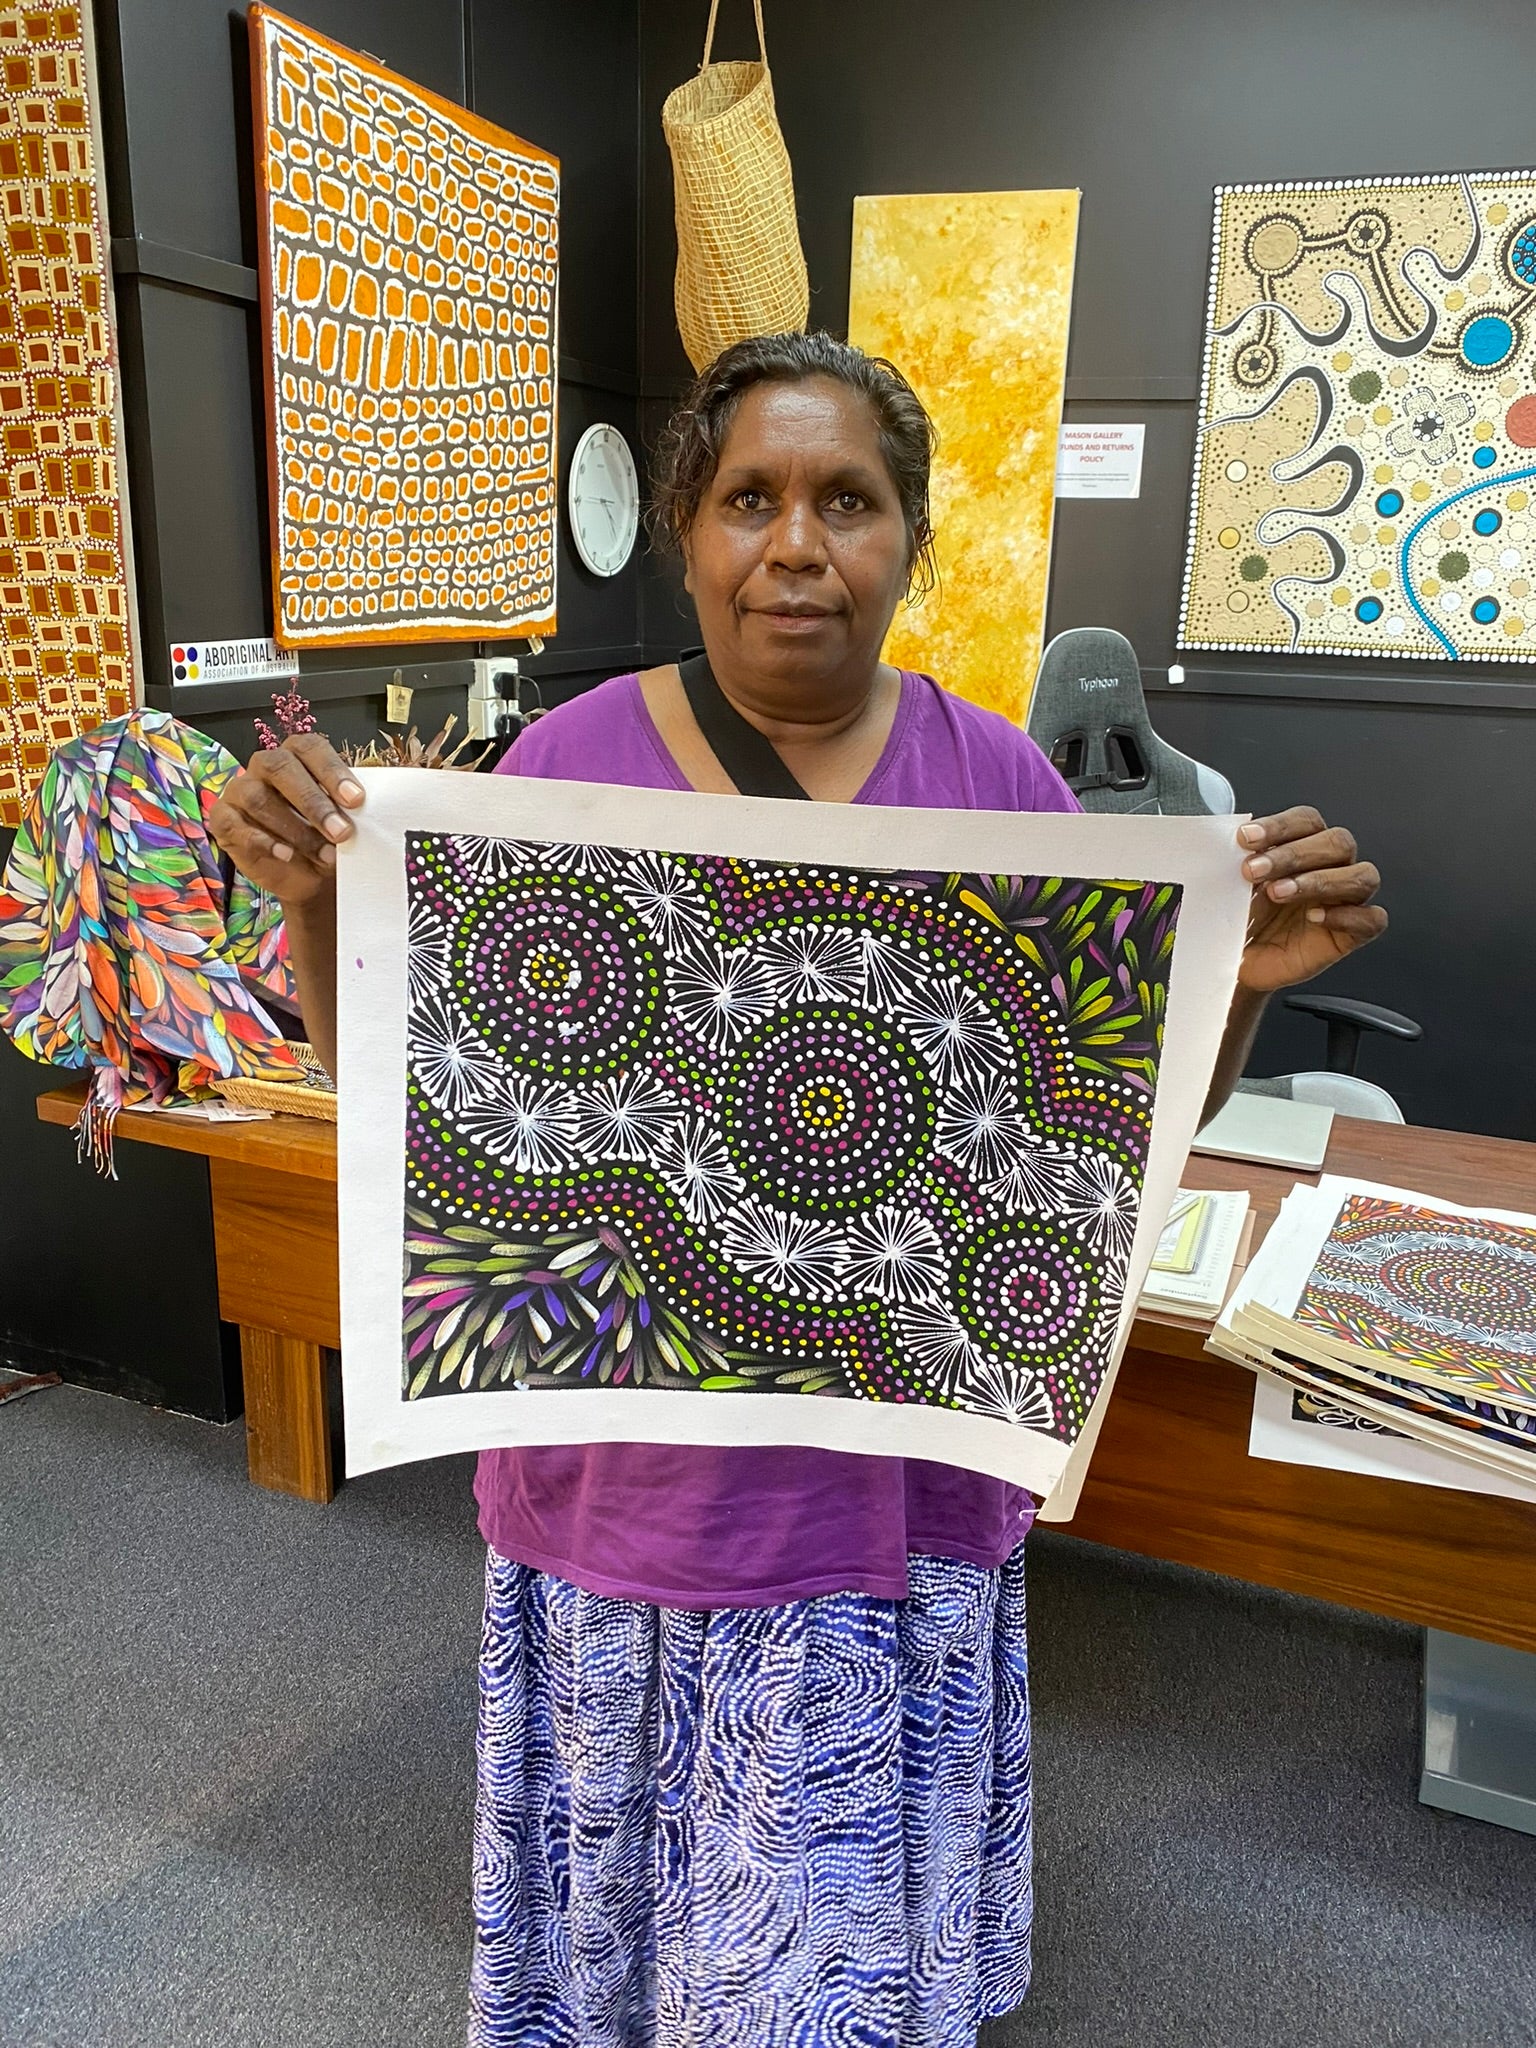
<box><xmin>37</xmin><ymin>1087</ymin><xmax>1536</xmax><ymax>1651</ymax></box>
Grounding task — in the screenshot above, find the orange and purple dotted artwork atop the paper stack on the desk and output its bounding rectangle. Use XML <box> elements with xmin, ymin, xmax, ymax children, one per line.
<box><xmin>1296</xmin><ymin>1194</ymin><xmax>1536</xmax><ymax>1401</ymax></box>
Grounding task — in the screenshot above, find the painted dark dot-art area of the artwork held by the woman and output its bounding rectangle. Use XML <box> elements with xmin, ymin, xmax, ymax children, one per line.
<box><xmin>403</xmin><ymin>834</ymin><xmax>1182</xmax><ymax>1444</ymax></box>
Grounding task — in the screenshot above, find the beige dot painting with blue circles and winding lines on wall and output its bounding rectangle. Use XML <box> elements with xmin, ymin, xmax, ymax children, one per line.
<box><xmin>1180</xmin><ymin>170</ymin><xmax>1536</xmax><ymax>662</ymax></box>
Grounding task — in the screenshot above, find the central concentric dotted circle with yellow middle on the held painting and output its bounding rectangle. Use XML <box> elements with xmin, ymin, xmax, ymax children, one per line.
<box><xmin>723</xmin><ymin>1006</ymin><xmax>936</xmax><ymax>1217</ymax></box>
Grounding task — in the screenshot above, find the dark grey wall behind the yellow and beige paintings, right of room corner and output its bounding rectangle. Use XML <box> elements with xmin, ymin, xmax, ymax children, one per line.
<box><xmin>641</xmin><ymin>0</ymin><xmax>1536</xmax><ymax>1137</ymax></box>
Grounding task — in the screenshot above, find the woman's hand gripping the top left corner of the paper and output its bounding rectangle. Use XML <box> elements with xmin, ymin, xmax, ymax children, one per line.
<box><xmin>209</xmin><ymin>733</ymin><xmax>362</xmax><ymax>911</ymax></box>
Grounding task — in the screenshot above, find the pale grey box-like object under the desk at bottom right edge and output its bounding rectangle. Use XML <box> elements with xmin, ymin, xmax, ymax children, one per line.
<box><xmin>1419</xmin><ymin>1628</ymin><xmax>1536</xmax><ymax>1835</ymax></box>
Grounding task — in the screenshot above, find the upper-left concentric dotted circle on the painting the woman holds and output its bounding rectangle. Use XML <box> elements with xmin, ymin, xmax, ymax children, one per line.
<box><xmin>453</xmin><ymin>874</ymin><xmax>659</xmax><ymax>1077</ymax></box>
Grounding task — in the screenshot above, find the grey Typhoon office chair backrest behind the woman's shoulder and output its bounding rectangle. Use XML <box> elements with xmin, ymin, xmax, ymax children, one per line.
<box><xmin>1028</xmin><ymin>627</ymin><xmax>1237</xmax><ymax>817</ymax></box>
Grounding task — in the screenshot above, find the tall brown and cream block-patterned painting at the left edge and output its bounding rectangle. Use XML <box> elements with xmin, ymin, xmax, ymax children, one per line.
<box><xmin>0</xmin><ymin>6</ymin><xmax>135</xmax><ymax>825</ymax></box>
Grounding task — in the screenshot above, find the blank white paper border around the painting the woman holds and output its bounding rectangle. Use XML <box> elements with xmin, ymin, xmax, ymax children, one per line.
<box><xmin>338</xmin><ymin>768</ymin><xmax>1249</xmax><ymax>1513</ymax></box>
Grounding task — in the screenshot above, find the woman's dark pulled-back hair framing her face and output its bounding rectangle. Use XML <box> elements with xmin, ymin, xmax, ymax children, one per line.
<box><xmin>651</xmin><ymin>334</ymin><xmax>938</xmax><ymax>602</ymax></box>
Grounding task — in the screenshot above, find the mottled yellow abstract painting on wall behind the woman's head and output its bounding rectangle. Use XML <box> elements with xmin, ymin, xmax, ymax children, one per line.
<box><xmin>848</xmin><ymin>193</ymin><xmax>1079</xmax><ymax>723</ymax></box>
